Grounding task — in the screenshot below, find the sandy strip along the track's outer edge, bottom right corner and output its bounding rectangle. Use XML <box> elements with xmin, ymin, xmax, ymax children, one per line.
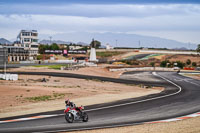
<box><xmin>70</xmin><ymin>117</ymin><xmax>200</xmax><ymax>133</ymax></box>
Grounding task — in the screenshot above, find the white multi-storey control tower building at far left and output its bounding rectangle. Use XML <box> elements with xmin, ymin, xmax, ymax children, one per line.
<box><xmin>17</xmin><ymin>30</ymin><xmax>38</xmax><ymax>60</ymax></box>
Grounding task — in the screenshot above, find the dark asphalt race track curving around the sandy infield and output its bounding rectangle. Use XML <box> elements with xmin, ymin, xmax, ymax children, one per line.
<box><xmin>0</xmin><ymin>72</ymin><xmax>200</xmax><ymax>133</ymax></box>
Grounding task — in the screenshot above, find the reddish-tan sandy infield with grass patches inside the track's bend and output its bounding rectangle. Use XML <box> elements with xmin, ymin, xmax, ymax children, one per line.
<box><xmin>0</xmin><ymin>67</ymin><xmax>163</xmax><ymax>117</ymax></box>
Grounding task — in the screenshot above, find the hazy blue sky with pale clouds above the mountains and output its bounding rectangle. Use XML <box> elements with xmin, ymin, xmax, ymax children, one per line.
<box><xmin>0</xmin><ymin>0</ymin><xmax>200</xmax><ymax>44</ymax></box>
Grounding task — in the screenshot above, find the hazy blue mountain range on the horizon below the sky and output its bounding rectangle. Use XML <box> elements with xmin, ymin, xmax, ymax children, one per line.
<box><xmin>40</xmin><ymin>32</ymin><xmax>197</xmax><ymax>49</ymax></box>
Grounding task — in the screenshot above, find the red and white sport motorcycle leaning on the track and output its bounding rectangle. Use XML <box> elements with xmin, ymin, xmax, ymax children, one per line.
<box><xmin>64</xmin><ymin>106</ymin><xmax>89</xmax><ymax>123</ymax></box>
